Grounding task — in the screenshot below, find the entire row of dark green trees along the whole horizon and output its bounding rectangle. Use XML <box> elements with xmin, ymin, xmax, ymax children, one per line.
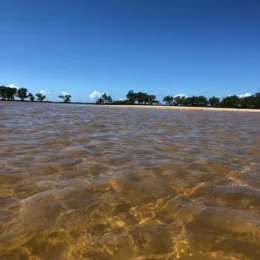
<box><xmin>0</xmin><ymin>85</ymin><xmax>260</xmax><ymax>108</ymax></box>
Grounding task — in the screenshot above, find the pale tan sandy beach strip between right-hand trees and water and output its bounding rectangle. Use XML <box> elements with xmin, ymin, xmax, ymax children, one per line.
<box><xmin>97</xmin><ymin>105</ymin><xmax>260</xmax><ymax>112</ymax></box>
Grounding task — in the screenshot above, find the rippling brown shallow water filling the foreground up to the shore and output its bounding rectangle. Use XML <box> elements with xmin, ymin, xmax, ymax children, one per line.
<box><xmin>0</xmin><ymin>102</ymin><xmax>260</xmax><ymax>260</ymax></box>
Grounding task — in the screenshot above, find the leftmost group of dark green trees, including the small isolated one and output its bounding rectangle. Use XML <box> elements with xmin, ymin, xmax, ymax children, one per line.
<box><xmin>0</xmin><ymin>85</ymin><xmax>71</xmax><ymax>103</ymax></box>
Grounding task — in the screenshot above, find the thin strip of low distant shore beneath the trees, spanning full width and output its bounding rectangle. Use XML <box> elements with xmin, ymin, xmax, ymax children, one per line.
<box><xmin>0</xmin><ymin>100</ymin><xmax>260</xmax><ymax>112</ymax></box>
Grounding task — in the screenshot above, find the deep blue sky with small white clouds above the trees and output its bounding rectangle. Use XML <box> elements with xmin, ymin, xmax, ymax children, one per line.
<box><xmin>0</xmin><ymin>0</ymin><xmax>260</xmax><ymax>102</ymax></box>
